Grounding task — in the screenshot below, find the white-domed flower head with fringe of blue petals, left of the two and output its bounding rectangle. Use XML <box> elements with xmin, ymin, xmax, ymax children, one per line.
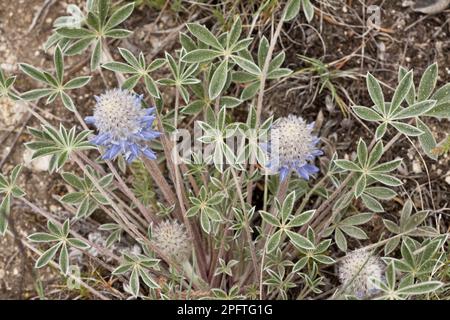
<box><xmin>85</xmin><ymin>89</ymin><xmax>161</xmax><ymax>163</ymax></box>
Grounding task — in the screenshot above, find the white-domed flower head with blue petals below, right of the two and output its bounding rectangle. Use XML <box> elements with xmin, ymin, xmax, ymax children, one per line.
<box><xmin>266</xmin><ymin>114</ymin><xmax>323</xmax><ymax>180</ymax></box>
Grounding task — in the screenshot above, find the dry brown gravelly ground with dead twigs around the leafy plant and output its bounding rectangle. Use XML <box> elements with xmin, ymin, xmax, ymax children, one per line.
<box><xmin>0</xmin><ymin>0</ymin><xmax>450</xmax><ymax>298</ymax></box>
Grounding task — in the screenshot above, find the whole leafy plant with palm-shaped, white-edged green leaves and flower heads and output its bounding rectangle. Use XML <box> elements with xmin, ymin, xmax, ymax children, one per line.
<box><xmin>0</xmin><ymin>0</ymin><xmax>450</xmax><ymax>299</ymax></box>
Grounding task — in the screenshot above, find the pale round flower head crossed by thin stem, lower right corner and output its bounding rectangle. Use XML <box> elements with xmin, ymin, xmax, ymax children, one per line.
<box><xmin>338</xmin><ymin>249</ymin><xmax>384</xmax><ymax>298</ymax></box>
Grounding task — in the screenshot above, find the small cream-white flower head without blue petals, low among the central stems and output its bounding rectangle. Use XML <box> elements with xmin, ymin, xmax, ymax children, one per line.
<box><xmin>152</xmin><ymin>220</ymin><xmax>192</xmax><ymax>262</ymax></box>
